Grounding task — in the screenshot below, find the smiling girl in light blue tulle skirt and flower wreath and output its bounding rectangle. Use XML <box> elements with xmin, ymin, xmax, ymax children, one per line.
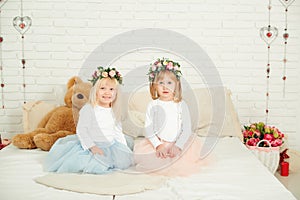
<box><xmin>44</xmin><ymin>67</ymin><xmax>133</xmax><ymax>174</ymax></box>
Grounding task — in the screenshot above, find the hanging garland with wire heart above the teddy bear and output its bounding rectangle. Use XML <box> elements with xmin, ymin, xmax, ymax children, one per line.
<box><xmin>13</xmin><ymin>0</ymin><xmax>32</xmax><ymax>104</ymax></box>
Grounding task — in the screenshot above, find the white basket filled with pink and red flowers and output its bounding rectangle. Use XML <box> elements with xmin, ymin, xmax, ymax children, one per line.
<box><xmin>243</xmin><ymin>122</ymin><xmax>284</xmax><ymax>174</ymax></box>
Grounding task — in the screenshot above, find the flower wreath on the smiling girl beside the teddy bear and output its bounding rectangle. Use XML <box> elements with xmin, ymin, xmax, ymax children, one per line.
<box><xmin>89</xmin><ymin>66</ymin><xmax>123</xmax><ymax>85</ymax></box>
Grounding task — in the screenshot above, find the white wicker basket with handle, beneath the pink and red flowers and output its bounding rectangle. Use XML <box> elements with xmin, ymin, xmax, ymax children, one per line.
<box><xmin>247</xmin><ymin>140</ymin><xmax>280</xmax><ymax>174</ymax></box>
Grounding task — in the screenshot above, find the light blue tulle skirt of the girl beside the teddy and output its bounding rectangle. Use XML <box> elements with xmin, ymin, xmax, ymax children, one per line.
<box><xmin>44</xmin><ymin>135</ymin><xmax>133</xmax><ymax>174</ymax></box>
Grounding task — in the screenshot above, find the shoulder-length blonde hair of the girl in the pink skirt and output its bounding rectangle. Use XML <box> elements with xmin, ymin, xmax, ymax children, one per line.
<box><xmin>149</xmin><ymin>70</ymin><xmax>182</xmax><ymax>103</ymax></box>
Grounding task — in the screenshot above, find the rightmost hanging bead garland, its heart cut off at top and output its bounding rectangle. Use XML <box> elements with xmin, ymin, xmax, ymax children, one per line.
<box><xmin>279</xmin><ymin>0</ymin><xmax>294</xmax><ymax>97</ymax></box>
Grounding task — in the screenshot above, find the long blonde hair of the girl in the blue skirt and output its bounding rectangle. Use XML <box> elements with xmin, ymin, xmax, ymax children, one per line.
<box><xmin>89</xmin><ymin>77</ymin><xmax>122</xmax><ymax>122</ymax></box>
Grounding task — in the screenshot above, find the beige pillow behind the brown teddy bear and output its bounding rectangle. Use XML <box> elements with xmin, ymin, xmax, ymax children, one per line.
<box><xmin>23</xmin><ymin>101</ymin><xmax>56</xmax><ymax>133</ymax></box>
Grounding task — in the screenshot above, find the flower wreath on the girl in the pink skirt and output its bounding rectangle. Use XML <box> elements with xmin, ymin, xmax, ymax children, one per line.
<box><xmin>147</xmin><ymin>58</ymin><xmax>182</xmax><ymax>83</ymax></box>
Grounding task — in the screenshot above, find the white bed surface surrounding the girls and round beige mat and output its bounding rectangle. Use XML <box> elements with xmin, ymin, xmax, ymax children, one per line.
<box><xmin>0</xmin><ymin>137</ymin><xmax>296</xmax><ymax>200</ymax></box>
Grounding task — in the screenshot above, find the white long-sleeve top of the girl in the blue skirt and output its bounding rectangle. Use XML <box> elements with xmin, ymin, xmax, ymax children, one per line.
<box><xmin>76</xmin><ymin>104</ymin><xmax>126</xmax><ymax>150</ymax></box>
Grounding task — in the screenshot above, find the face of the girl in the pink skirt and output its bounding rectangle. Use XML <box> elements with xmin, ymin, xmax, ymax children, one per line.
<box><xmin>156</xmin><ymin>75</ymin><xmax>176</xmax><ymax>101</ymax></box>
